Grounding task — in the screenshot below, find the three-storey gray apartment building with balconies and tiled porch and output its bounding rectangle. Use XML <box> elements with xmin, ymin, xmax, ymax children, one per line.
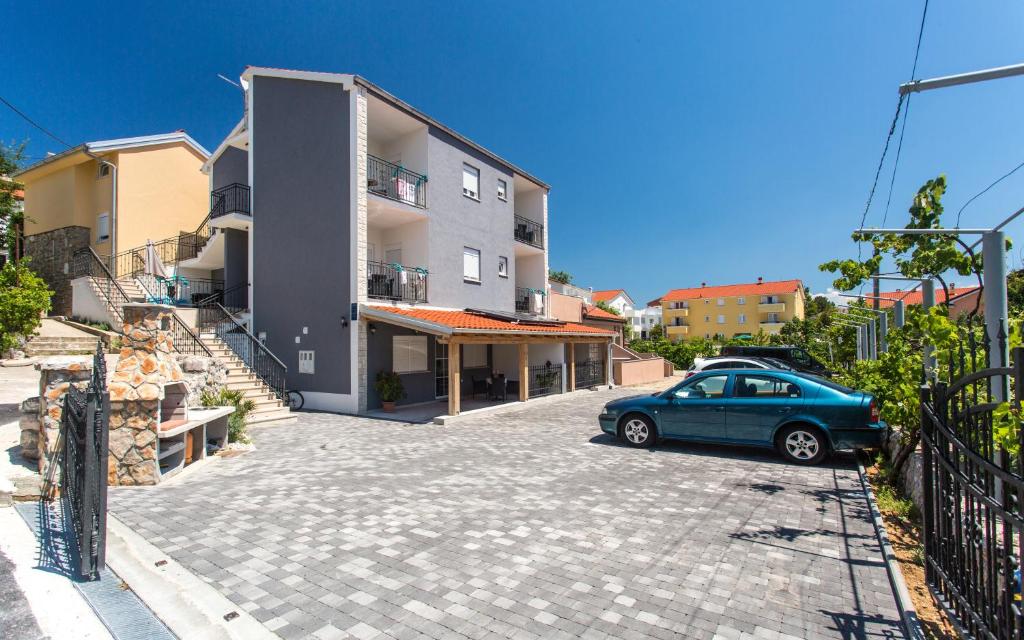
<box><xmin>206</xmin><ymin>68</ymin><xmax>614</xmax><ymax>414</ymax></box>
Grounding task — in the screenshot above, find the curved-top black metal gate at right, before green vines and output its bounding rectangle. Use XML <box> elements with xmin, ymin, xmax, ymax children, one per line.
<box><xmin>921</xmin><ymin>328</ymin><xmax>1024</xmax><ymax>640</ymax></box>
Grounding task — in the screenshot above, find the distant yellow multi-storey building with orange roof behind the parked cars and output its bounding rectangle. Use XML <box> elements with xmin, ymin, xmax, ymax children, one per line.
<box><xmin>658</xmin><ymin>278</ymin><xmax>806</xmax><ymax>342</ymax></box>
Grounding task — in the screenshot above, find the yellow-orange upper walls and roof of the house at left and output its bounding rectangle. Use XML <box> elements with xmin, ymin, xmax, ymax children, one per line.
<box><xmin>13</xmin><ymin>131</ymin><xmax>210</xmax><ymax>256</ymax></box>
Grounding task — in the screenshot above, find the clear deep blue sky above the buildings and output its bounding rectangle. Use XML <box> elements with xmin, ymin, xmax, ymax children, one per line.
<box><xmin>6</xmin><ymin>0</ymin><xmax>1024</xmax><ymax>302</ymax></box>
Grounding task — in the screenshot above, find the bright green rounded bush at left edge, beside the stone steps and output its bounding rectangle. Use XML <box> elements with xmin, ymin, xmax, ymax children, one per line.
<box><xmin>0</xmin><ymin>258</ymin><xmax>53</xmax><ymax>352</ymax></box>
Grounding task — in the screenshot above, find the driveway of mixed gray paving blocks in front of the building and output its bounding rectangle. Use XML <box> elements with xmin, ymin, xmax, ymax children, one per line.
<box><xmin>110</xmin><ymin>390</ymin><xmax>900</xmax><ymax>639</ymax></box>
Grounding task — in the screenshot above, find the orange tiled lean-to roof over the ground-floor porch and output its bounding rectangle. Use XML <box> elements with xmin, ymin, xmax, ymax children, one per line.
<box><xmin>365</xmin><ymin>305</ymin><xmax>616</xmax><ymax>338</ymax></box>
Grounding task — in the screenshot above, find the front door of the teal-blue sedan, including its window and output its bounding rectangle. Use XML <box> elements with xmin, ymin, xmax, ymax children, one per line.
<box><xmin>660</xmin><ymin>374</ymin><xmax>729</xmax><ymax>440</ymax></box>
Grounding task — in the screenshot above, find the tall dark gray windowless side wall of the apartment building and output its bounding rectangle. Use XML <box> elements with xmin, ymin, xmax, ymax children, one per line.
<box><xmin>250</xmin><ymin>76</ymin><xmax>355</xmax><ymax>394</ymax></box>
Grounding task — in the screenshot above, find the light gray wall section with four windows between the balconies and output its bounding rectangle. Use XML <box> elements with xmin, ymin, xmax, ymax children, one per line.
<box><xmin>427</xmin><ymin>127</ymin><xmax>515</xmax><ymax>312</ymax></box>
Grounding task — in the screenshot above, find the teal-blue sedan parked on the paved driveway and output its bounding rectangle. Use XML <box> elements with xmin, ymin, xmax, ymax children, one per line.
<box><xmin>598</xmin><ymin>369</ymin><xmax>886</xmax><ymax>464</ymax></box>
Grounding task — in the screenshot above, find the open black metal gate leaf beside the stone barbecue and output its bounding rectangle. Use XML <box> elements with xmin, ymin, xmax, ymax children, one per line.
<box><xmin>57</xmin><ymin>343</ymin><xmax>111</xmax><ymax>580</ymax></box>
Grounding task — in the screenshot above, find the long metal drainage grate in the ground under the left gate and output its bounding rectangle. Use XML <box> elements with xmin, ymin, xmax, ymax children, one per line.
<box><xmin>15</xmin><ymin>501</ymin><xmax>176</xmax><ymax>640</ymax></box>
